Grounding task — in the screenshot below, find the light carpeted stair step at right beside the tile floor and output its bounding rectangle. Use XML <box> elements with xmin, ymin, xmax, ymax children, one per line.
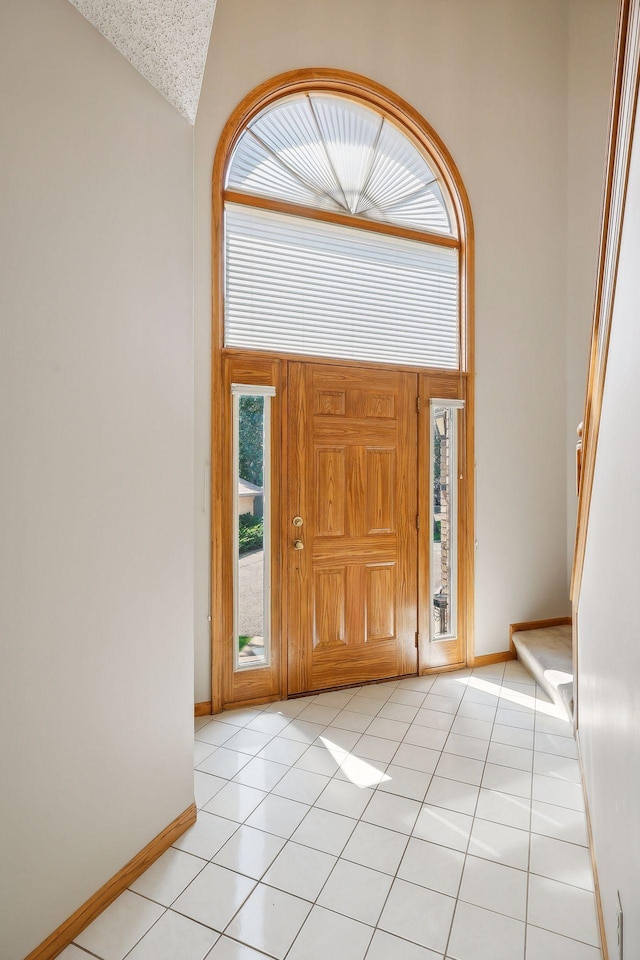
<box><xmin>512</xmin><ymin>624</ymin><xmax>573</xmax><ymax>719</ymax></box>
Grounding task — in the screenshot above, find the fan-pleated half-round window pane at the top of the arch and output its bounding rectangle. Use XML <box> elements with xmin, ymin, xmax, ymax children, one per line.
<box><xmin>226</xmin><ymin>93</ymin><xmax>456</xmax><ymax>236</ymax></box>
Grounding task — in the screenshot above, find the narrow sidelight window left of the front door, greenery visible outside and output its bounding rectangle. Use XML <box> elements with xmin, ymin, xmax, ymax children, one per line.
<box><xmin>231</xmin><ymin>383</ymin><xmax>275</xmax><ymax>670</ymax></box>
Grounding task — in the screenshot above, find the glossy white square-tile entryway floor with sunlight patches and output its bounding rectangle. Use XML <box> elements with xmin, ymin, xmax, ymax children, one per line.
<box><xmin>62</xmin><ymin>662</ymin><xmax>601</xmax><ymax>960</ymax></box>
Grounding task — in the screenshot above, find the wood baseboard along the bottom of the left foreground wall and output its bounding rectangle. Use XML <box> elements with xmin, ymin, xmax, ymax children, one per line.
<box><xmin>25</xmin><ymin>803</ymin><xmax>197</xmax><ymax>960</ymax></box>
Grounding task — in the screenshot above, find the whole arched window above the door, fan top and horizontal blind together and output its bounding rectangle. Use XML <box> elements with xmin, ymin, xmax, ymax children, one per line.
<box><xmin>224</xmin><ymin>90</ymin><xmax>464</xmax><ymax>370</ymax></box>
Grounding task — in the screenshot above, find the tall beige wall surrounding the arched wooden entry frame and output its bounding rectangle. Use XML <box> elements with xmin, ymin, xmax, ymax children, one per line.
<box><xmin>195</xmin><ymin>0</ymin><xmax>611</xmax><ymax>700</ymax></box>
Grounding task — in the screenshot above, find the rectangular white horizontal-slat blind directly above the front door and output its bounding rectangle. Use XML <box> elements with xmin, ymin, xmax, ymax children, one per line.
<box><xmin>225</xmin><ymin>204</ymin><xmax>459</xmax><ymax>370</ymax></box>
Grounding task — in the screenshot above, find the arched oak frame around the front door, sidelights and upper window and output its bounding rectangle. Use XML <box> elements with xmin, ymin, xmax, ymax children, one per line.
<box><xmin>211</xmin><ymin>68</ymin><xmax>478</xmax><ymax>713</ymax></box>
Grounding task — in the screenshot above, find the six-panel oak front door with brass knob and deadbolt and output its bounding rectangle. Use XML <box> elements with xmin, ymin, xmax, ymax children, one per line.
<box><xmin>285</xmin><ymin>362</ymin><xmax>418</xmax><ymax>694</ymax></box>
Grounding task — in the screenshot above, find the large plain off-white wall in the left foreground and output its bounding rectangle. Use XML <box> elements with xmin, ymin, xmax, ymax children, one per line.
<box><xmin>0</xmin><ymin>0</ymin><xmax>193</xmax><ymax>960</ymax></box>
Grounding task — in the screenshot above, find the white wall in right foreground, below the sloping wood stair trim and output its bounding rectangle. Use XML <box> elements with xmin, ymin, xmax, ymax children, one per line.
<box><xmin>578</xmin><ymin>94</ymin><xmax>640</xmax><ymax>960</ymax></box>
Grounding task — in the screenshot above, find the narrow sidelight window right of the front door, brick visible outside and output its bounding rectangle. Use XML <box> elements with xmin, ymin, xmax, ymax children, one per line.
<box><xmin>430</xmin><ymin>400</ymin><xmax>464</xmax><ymax>640</ymax></box>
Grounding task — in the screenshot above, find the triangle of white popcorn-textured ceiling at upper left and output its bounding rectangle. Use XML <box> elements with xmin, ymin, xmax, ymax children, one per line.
<box><xmin>71</xmin><ymin>0</ymin><xmax>216</xmax><ymax>123</ymax></box>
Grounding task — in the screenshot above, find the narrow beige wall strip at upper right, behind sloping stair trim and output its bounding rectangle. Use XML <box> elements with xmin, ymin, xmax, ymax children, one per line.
<box><xmin>566</xmin><ymin>0</ymin><xmax>618</xmax><ymax>575</ymax></box>
